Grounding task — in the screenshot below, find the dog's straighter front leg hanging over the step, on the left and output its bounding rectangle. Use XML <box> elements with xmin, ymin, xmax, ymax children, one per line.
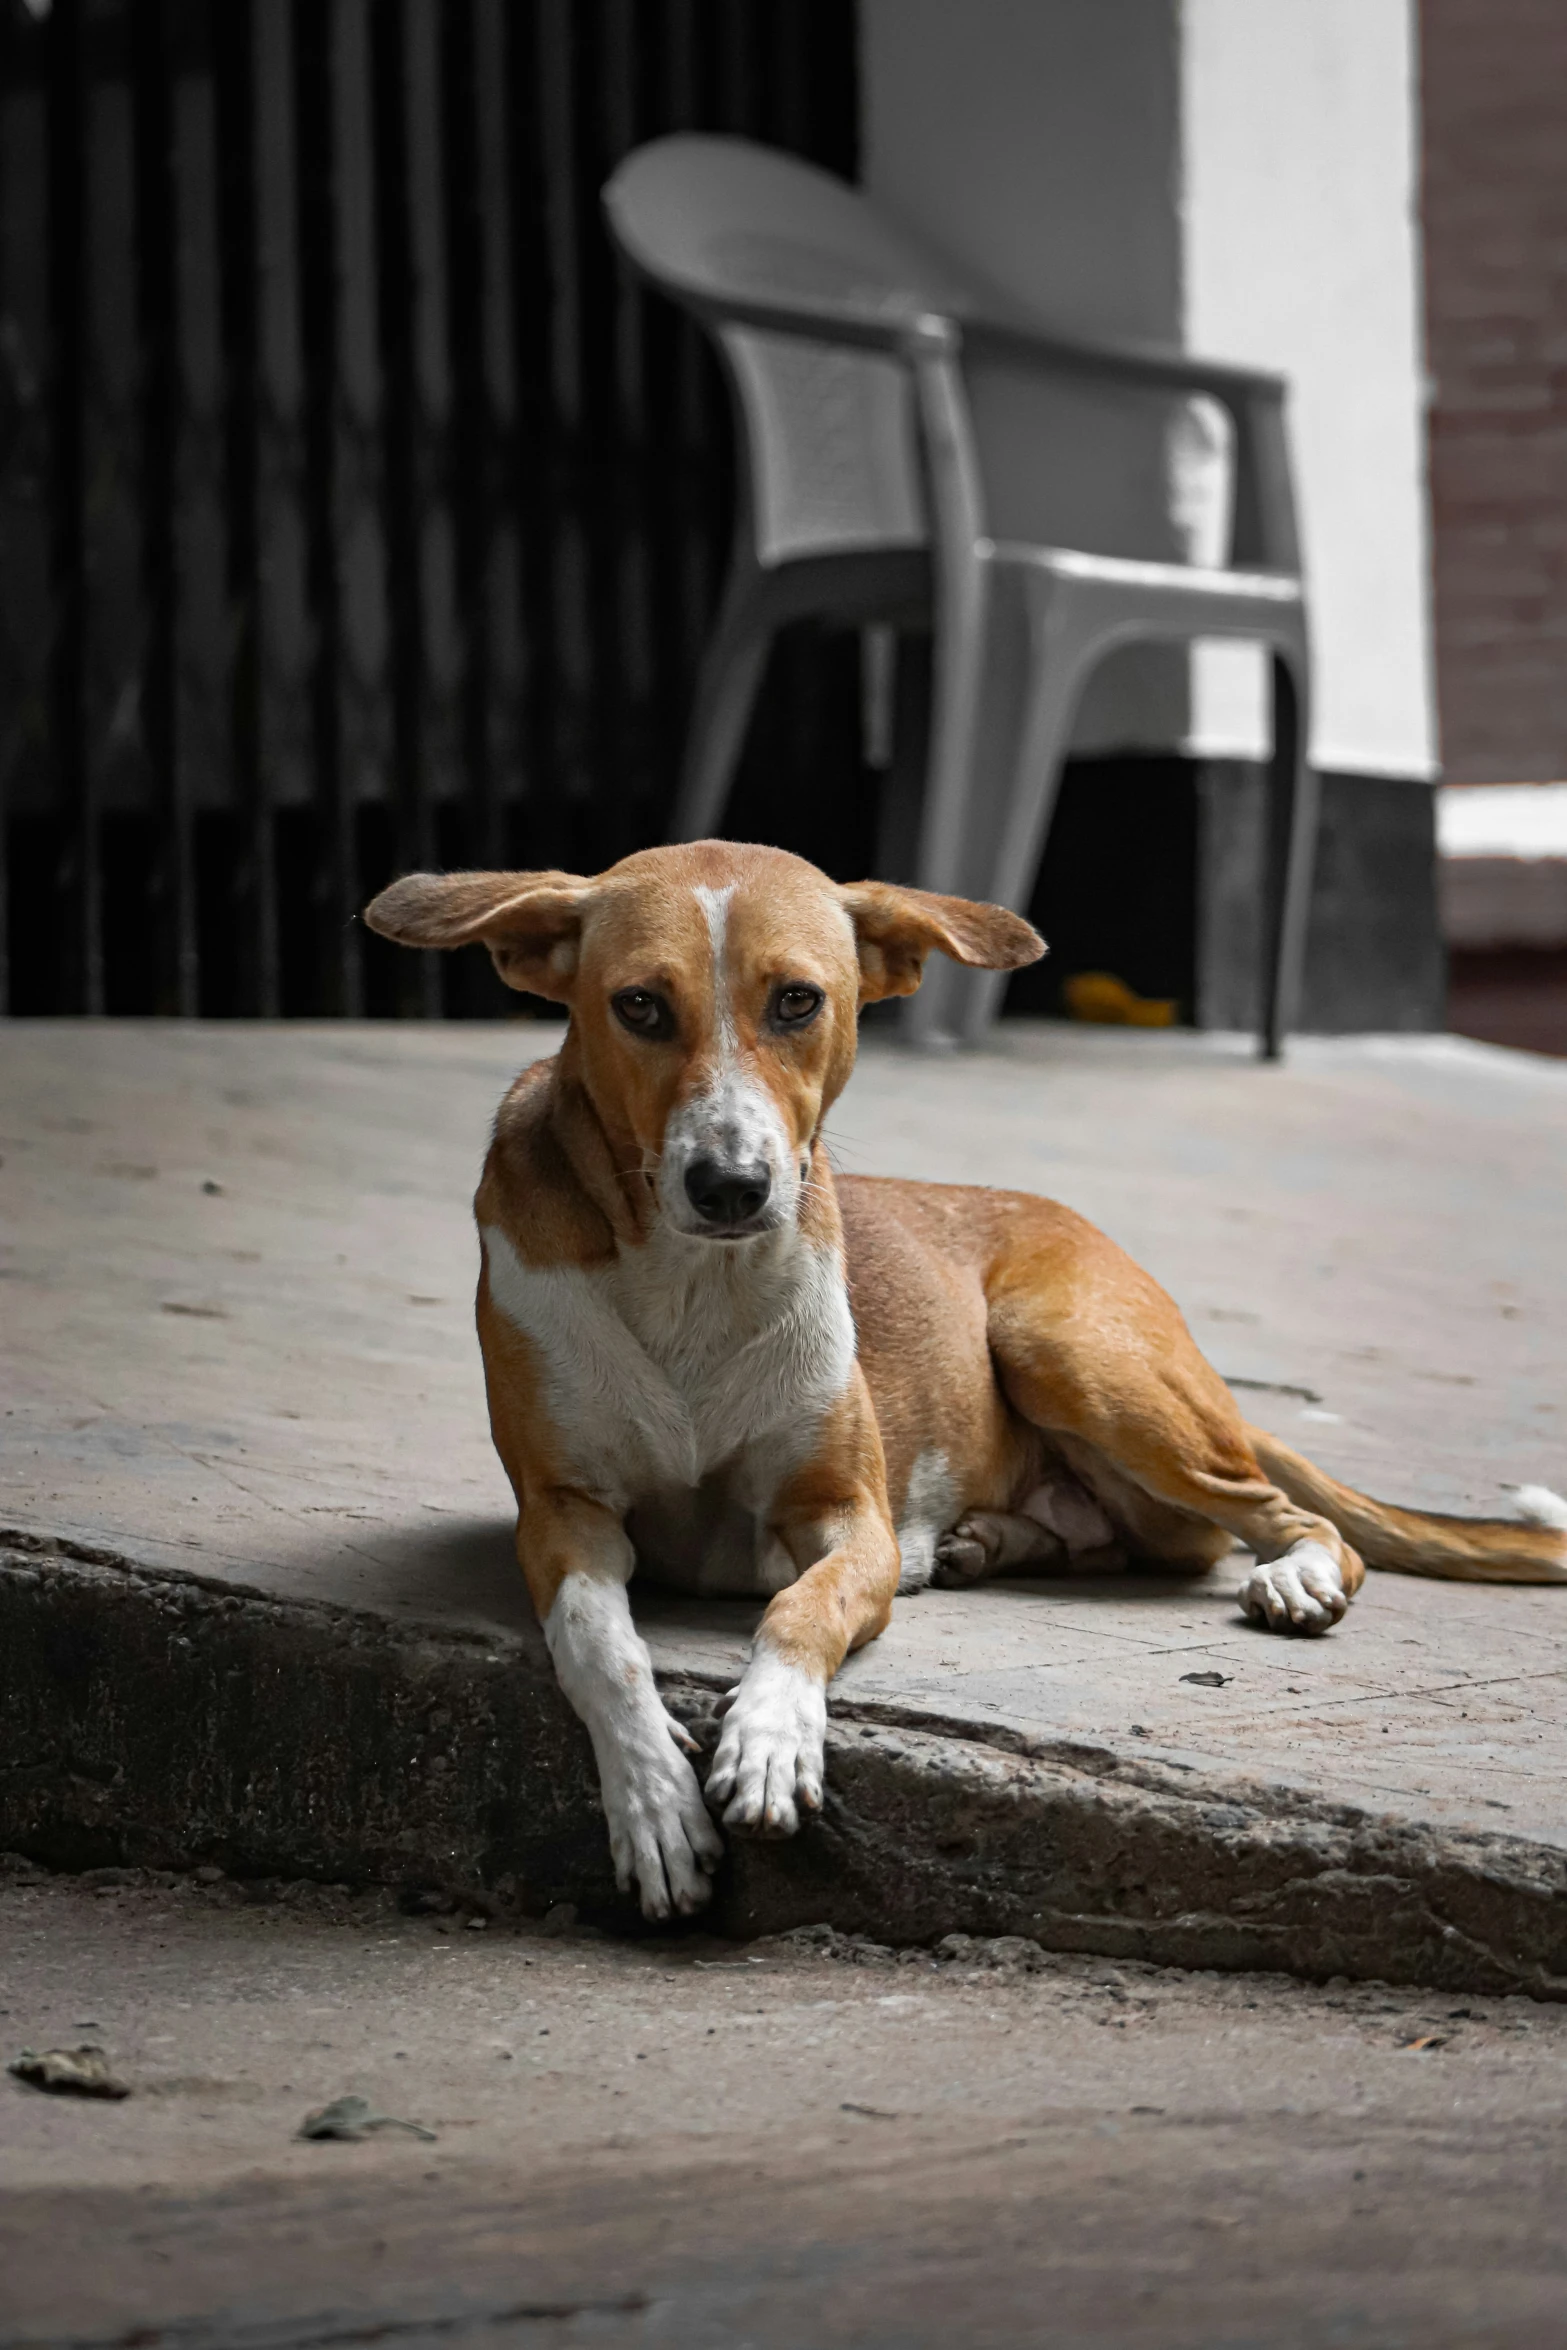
<box><xmin>517</xmin><ymin>1492</ymin><xmax>724</xmax><ymax>1918</ymax></box>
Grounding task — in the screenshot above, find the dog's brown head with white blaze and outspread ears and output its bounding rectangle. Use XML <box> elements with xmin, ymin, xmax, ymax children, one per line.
<box><xmin>364</xmin><ymin>841</ymin><xmax>1043</xmax><ymax>1241</ymax></box>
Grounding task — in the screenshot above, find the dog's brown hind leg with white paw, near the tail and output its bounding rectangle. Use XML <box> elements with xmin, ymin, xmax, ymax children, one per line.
<box><xmin>987</xmin><ymin>1213</ymin><xmax>1365</xmax><ymax>1633</ymax></box>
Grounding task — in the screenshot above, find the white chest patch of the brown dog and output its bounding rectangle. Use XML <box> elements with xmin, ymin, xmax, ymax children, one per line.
<box><xmin>482</xmin><ymin>1224</ymin><xmax>855</xmax><ymax>1511</ymax></box>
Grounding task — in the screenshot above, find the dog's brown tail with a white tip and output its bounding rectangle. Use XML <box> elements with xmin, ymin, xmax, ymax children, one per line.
<box><xmin>1247</xmin><ymin>1429</ymin><xmax>1567</xmax><ymax>1584</ymax></box>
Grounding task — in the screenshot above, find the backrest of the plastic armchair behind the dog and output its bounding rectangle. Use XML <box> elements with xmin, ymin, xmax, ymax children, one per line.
<box><xmin>604</xmin><ymin>139</ymin><xmax>966</xmax><ymax>564</ymax></box>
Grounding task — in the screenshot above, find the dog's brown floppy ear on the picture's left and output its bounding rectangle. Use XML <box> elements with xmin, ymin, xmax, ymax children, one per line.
<box><xmin>364</xmin><ymin>874</ymin><xmax>594</xmax><ymax>1003</ymax></box>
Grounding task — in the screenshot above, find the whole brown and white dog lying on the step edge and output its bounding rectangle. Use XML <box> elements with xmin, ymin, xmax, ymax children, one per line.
<box><xmin>364</xmin><ymin>841</ymin><xmax>1567</xmax><ymax>1918</ymax></box>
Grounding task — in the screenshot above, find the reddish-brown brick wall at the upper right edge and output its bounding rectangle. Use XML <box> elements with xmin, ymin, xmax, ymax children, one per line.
<box><xmin>1421</xmin><ymin>0</ymin><xmax>1567</xmax><ymax>783</ymax></box>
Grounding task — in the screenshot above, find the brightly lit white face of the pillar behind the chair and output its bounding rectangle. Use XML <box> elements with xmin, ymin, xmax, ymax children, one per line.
<box><xmin>1188</xmin><ymin>0</ymin><xmax>1435</xmax><ymax>776</ymax></box>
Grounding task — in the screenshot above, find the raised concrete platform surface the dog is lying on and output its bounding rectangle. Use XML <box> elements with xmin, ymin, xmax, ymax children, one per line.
<box><xmin>0</xmin><ymin>1022</ymin><xmax>1567</xmax><ymax>1976</ymax></box>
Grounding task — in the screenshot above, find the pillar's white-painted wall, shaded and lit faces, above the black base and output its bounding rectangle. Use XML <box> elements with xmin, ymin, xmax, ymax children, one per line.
<box><xmin>860</xmin><ymin>0</ymin><xmax>1433</xmax><ymax>776</ymax></box>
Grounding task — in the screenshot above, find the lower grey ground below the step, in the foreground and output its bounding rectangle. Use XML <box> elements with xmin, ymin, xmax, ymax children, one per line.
<box><xmin>0</xmin><ymin>1871</ymin><xmax>1567</xmax><ymax>2350</ymax></box>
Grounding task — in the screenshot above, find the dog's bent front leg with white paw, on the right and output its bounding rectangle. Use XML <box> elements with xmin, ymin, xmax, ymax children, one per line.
<box><xmin>707</xmin><ymin>1428</ymin><xmax>900</xmax><ymax>1835</ymax></box>
